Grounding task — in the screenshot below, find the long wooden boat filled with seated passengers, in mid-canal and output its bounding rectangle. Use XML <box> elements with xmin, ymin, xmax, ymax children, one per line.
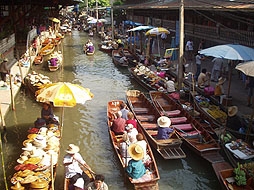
<box><xmin>107</xmin><ymin>101</ymin><xmax>160</xmax><ymax>190</ymax></box>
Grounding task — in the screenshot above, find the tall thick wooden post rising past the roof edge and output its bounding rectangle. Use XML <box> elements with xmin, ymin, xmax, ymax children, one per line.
<box><xmin>178</xmin><ymin>0</ymin><xmax>184</xmax><ymax>90</ymax></box>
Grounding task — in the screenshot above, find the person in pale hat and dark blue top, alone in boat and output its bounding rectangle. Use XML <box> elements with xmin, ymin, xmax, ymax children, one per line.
<box><xmin>157</xmin><ymin>116</ymin><xmax>174</xmax><ymax>140</ymax></box>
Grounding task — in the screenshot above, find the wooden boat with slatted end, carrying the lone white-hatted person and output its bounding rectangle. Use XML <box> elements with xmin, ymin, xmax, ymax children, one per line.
<box><xmin>126</xmin><ymin>90</ymin><xmax>186</xmax><ymax>159</ymax></box>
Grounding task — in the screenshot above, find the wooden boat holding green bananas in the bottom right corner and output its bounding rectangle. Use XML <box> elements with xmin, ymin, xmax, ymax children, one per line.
<box><xmin>220</xmin><ymin>169</ymin><xmax>254</xmax><ymax>190</ymax></box>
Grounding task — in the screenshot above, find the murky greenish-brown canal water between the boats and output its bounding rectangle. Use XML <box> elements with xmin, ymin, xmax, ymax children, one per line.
<box><xmin>0</xmin><ymin>31</ymin><xmax>220</xmax><ymax>190</ymax></box>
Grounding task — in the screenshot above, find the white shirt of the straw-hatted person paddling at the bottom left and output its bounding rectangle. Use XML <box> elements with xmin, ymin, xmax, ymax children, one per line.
<box><xmin>63</xmin><ymin>153</ymin><xmax>86</xmax><ymax>178</ymax></box>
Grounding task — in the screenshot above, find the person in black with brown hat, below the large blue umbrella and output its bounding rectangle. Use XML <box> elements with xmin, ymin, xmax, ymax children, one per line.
<box><xmin>226</xmin><ymin>106</ymin><xmax>245</xmax><ymax>134</ymax></box>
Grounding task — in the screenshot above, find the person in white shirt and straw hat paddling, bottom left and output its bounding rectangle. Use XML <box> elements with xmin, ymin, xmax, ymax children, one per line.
<box><xmin>63</xmin><ymin>144</ymin><xmax>91</xmax><ymax>190</ymax></box>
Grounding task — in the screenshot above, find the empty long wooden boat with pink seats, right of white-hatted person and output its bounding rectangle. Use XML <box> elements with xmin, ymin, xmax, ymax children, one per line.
<box><xmin>150</xmin><ymin>92</ymin><xmax>221</xmax><ymax>162</ymax></box>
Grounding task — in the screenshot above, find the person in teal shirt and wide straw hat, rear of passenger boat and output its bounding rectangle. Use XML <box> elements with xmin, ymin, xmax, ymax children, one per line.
<box><xmin>125</xmin><ymin>144</ymin><xmax>146</xmax><ymax>179</ymax></box>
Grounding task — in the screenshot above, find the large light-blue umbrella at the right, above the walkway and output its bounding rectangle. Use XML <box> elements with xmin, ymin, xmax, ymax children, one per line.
<box><xmin>199</xmin><ymin>44</ymin><xmax>254</xmax><ymax>61</ymax></box>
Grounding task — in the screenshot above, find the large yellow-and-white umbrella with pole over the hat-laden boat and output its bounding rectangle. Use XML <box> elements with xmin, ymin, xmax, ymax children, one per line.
<box><xmin>36</xmin><ymin>82</ymin><xmax>93</xmax><ymax>134</ymax></box>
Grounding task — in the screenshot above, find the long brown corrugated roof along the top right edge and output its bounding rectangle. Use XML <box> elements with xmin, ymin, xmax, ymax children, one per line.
<box><xmin>115</xmin><ymin>0</ymin><xmax>254</xmax><ymax>11</ymax></box>
